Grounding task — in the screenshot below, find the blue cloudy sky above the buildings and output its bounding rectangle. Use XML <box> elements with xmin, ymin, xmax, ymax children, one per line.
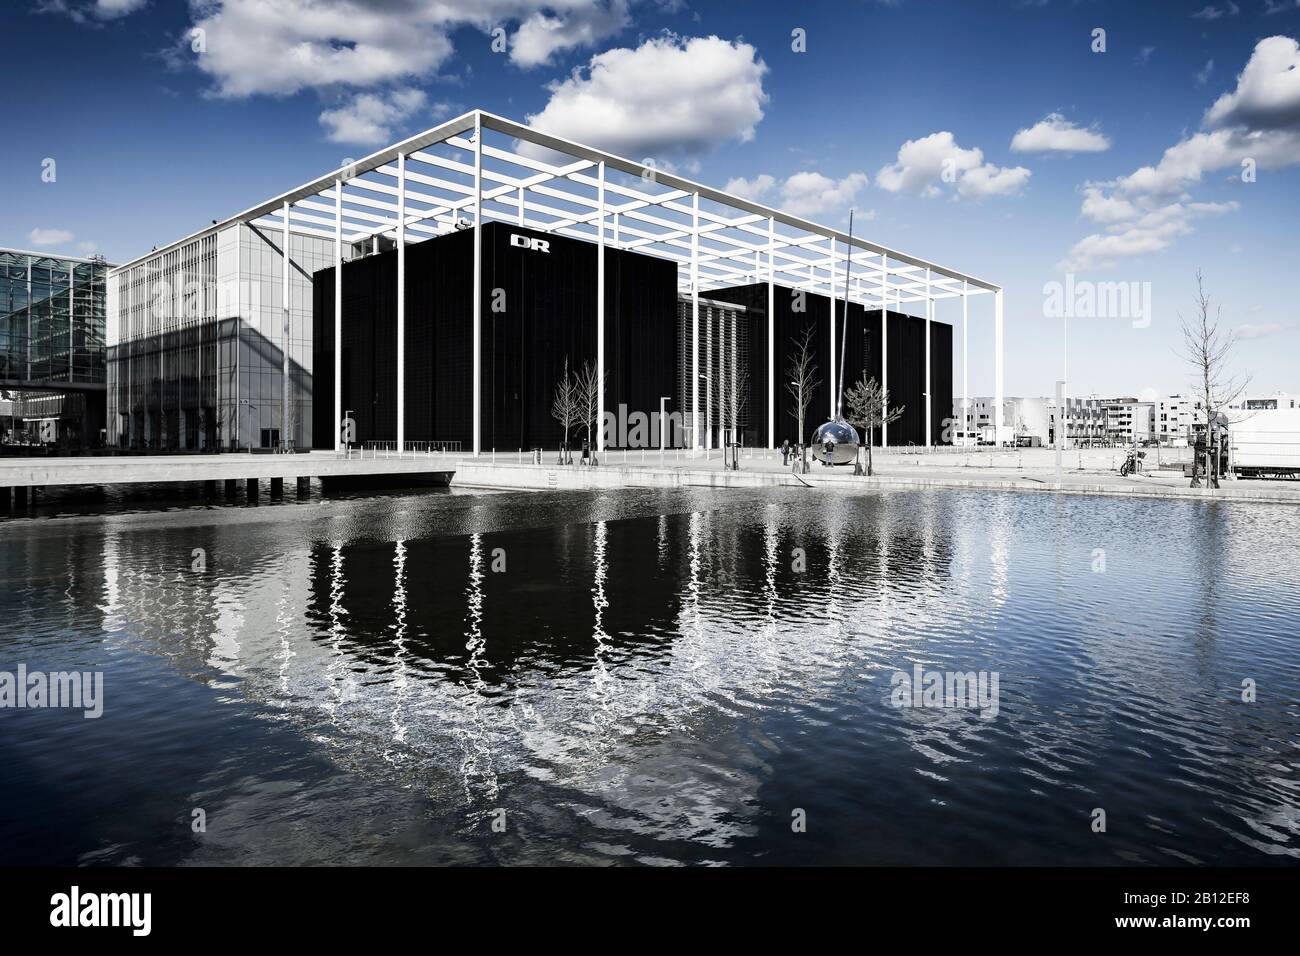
<box><xmin>0</xmin><ymin>0</ymin><xmax>1300</xmax><ymax>395</ymax></box>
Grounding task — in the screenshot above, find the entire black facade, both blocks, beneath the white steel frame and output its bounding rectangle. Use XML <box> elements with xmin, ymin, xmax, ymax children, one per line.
<box><xmin>312</xmin><ymin>222</ymin><xmax>952</xmax><ymax>451</ymax></box>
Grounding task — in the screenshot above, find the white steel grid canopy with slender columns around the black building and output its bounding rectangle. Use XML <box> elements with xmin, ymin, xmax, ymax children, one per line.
<box><xmin>111</xmin><ymin>111</ymin><xmax>1005</xmax><ymax>455</ymax></box>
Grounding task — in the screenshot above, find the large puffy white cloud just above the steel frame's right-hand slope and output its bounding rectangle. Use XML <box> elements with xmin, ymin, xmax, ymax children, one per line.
<box><xmin>528</xmin><ymin>34</ymin><xmax>767</xmax><ymax>158</ymax></box>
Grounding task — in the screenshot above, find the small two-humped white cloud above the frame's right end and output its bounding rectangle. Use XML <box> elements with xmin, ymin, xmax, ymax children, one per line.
<box><xmin>876</xmin><ymin>130</ymin><xmax>1031</xmax><ymax>199</ymax></box>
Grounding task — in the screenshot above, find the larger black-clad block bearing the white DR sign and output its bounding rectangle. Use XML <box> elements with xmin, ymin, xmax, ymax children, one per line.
<box><xmin>312</xmin><ymin>222</ymin><xmax>677</xmax><ymax>450</ymax></box>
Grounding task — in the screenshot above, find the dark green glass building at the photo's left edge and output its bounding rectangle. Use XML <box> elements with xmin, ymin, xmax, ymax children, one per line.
<box><xmin>0</xmin><ymin>248</ymin><xmax>111</xmax><ymax>449</ymax></box>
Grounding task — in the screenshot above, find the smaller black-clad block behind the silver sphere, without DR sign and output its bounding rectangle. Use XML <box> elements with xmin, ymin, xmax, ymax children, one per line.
<box><xmin>707</xmin><ymin>282</ymin><xmax>953</xmax><ymax>446</ymax></box>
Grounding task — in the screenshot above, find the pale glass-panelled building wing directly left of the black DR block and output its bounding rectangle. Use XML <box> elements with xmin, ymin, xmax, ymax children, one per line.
<box><xmin>108</xmin><ymin>224</ymin><xmax>334</xmax><ymax>451</ymax></box>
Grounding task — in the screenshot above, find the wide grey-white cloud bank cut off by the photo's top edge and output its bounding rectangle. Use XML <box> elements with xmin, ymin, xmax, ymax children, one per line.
<box><xmin>185</xmin><ymin>0</ymin><xmax>628</xmax><ymax>96</ymax></box>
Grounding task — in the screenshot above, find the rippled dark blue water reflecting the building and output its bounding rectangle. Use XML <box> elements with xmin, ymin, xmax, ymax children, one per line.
<box><xmin>0</xmin><ymin>489</ymin><xmax>1300</xmax><ymax>865</ymax></box>
